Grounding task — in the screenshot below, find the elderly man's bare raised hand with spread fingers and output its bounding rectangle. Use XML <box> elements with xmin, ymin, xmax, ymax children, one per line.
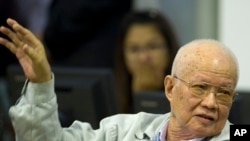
<box><xmin>0</xmin><ymin>18</ymin><xmax>51</xmax><ymax>82</ymax></box>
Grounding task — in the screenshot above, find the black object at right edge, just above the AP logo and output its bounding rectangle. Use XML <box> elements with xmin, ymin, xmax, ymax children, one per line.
<box><xmin>228</xmin><ymin>91</ymin><xmax>250</xmax><ymax>124</ymax></box>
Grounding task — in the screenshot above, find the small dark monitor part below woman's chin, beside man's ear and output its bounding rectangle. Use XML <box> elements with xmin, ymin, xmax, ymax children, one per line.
<box><xmin>133</xmin><ymin>91</ymin><xmax>170</xmax><ymax>114</ymax></box>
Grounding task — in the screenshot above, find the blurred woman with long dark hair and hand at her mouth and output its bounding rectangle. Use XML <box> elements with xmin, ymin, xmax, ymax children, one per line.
<box><xmin>115</xmin><ymin>10</ymin><xmax>179</xmax><ymax>113</ymax></box>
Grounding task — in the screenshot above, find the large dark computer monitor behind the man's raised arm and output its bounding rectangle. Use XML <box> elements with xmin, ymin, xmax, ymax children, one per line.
<box><xmin>7</xmin><ymin>65</ymin><xmax>117</xmax><ymax>128</ymax></box>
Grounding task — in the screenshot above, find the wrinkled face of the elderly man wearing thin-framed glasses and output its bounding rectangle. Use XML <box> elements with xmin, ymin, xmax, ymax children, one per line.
<box><xmin>165</xmin><ymin>43</ymin><xmax>237</xmax><ymax>137</ymax></box>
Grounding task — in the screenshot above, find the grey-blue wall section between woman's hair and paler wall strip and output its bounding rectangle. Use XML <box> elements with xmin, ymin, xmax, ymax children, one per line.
<box><xmin>134</xmin><ymin>0</ymin><xmax>196</xmax><ymax>44</ymax></box>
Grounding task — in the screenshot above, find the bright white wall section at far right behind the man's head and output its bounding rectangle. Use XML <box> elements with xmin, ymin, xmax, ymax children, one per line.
<box><xmin>218</xmin><ymin>0</ymin><xmax>250</xmax><ymax>91</ymax></box>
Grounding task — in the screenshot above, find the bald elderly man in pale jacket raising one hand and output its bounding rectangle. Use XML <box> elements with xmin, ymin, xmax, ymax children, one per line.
<box><xmin>0</xmin><ymin>19</ymin><xmax>238</xmax><ymax>141</ymax></box>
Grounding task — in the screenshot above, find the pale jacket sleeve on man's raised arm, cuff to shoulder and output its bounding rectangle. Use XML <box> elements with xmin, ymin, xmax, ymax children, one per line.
<box><xmin>9</xmin><ymin>76</ymin><xmax>117</xmax><ymax>141</ymax></box>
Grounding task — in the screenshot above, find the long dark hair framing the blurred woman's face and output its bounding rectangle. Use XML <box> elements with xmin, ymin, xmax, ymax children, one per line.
<box><xmin>115</xmin><ymin>10</ymin><xmax>179</xmax><ymax>112</ymax></box>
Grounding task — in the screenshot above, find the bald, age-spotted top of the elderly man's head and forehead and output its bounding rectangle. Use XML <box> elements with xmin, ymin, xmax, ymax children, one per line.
<box><xmin>173</xmin><ymin>40</ymin><xmax>238</xmax><ymax>81</ymax></box>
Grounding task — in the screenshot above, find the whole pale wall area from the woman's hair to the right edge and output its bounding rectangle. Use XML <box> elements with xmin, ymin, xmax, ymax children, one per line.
<box><xmin>134</xmin><ymin>0</ymin><xmax>250</xmax><ymax>91</ymax></box>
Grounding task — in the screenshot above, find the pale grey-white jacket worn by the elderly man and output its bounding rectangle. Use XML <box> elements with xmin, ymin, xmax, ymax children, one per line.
<box><xmin>9</xmin><ymin>78</ymin><xmax>230</xmax><ymax>141</ymax></box>
